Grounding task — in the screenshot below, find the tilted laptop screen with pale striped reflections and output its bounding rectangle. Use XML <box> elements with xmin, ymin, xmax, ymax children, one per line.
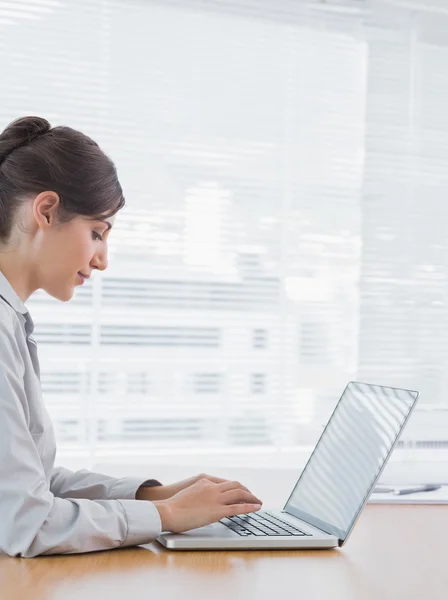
<box><xmin>284</xmin><ymin>381</ymin><xmax>418</xmax><ymax>542</ymax></box>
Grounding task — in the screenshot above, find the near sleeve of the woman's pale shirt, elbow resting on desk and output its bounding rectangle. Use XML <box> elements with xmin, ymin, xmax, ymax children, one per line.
<box><xmin>0</xmin><ymin>321</ymin><xmax>161</xmax><ymax>557</ymax></box>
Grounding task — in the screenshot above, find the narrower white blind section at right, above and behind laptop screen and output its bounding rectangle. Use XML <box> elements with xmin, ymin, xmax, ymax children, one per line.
<box><xmin>359</xmin><ymin>1</ymin><xmax>448</xmax><ymax>458</ymax></box>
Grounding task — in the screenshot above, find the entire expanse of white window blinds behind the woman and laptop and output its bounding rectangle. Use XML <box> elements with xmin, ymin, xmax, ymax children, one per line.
<box><xmin>0</xmin><ymin>0</ymin><xmax>448</xmax><ymax>468</ymax></box>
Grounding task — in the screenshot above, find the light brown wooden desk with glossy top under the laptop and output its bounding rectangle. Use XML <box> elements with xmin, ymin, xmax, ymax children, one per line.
<box><xmin>0</xmin><ymin>505</ymin><xmax>448</xmax><ymax>600</ymax></box>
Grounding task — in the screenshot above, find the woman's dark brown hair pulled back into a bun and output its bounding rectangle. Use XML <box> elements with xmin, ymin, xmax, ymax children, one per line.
<box><xmin>0</xmin><ymin>117</ymin><xmax>125</xmax><ymax>241</ymax></box>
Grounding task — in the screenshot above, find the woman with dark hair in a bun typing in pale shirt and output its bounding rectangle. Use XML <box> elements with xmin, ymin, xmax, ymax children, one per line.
<box><xmin>0</xmin><ymin>117</ymin><xmax>261</xmax><ymax>557</ymax></box>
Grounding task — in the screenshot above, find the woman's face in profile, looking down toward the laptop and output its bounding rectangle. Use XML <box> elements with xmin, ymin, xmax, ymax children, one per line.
<box><xmin>30</xmin><ymin>195</ymin><xmax>115</xmax><ymax>302</ymax></box>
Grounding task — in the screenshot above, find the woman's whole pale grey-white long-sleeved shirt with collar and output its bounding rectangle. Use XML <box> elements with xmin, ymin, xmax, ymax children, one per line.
<box><xmin>0</xmin><ymin>272</ymin><xmax>161</xmax><ymax>557</ymax></box>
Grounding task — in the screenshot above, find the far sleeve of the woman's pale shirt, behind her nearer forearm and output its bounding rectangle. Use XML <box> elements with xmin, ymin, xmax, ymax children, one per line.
<box><xmin>50</xmin><ymin>467</ymin><xmax>162</xmax><ymax>500</ymax></box>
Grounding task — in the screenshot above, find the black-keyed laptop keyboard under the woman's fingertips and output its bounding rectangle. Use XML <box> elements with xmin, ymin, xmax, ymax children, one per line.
<box><xmin>220</xmin><ymin>512</ymin><xmax>311</xmax><ymax>537</ymax></box>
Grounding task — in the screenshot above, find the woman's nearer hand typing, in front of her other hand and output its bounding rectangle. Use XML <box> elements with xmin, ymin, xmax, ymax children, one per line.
<box><xmin>154</xmin><ymin>478</ymin><xmax>262</xmax><ymax>533</ymax></box>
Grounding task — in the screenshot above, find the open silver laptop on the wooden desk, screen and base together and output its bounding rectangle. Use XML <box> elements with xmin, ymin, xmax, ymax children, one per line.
<box><xmin>158</xmin><ymin>381</ymin><xmax>419</xmax><ymax>550</ymax></box>
